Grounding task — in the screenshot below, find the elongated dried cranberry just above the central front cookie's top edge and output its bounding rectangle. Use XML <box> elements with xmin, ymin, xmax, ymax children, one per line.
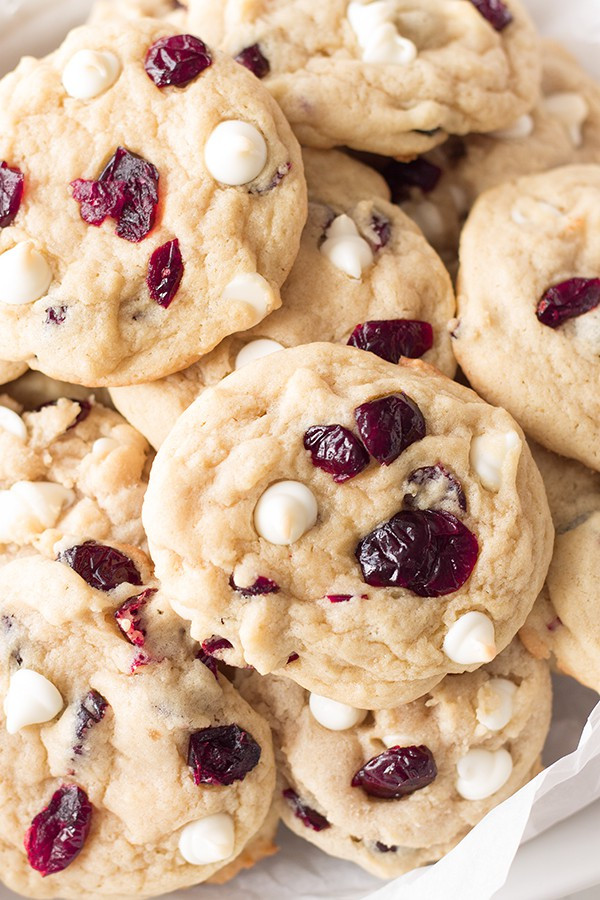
<box><xmin>348</xmin><ymin>319</ymin><xmax>433</xmax><ymax>363</ymax></box>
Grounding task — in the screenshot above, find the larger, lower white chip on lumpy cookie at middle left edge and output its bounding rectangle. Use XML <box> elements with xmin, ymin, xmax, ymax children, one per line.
<box><xmin>0</xmin><ymin>481</ymin><xmax>75</xmax><ymax>544</ymax></box>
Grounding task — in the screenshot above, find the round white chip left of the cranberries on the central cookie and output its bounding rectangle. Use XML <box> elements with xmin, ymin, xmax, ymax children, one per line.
<box><xmin>254</xmin><ymin>481</ymin><xmax>319</xmax><ymax>546</ymax></box>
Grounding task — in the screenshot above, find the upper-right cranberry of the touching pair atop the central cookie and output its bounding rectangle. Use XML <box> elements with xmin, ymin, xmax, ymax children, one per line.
<box><xmin>354</xmin><ymin>394</ymin><xmax>426</xmax><ymax>466</ymax></box>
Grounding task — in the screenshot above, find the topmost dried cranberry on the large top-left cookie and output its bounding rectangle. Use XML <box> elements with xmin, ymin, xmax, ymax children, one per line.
<box><xmin>144</xmin><ymin>34</ymin><xmax>212</xmax><ymax>88</ymax></box>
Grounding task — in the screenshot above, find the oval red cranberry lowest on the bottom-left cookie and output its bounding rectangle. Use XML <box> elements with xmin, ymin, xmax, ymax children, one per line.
<box><xmin>25</xmin><ymin>784</ymin><xmax>92</xmax><ymax>878</ymax></box>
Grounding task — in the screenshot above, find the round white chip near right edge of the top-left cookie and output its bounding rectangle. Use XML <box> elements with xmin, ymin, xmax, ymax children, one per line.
<box><xmin>204</xmin><ymin>119</ymin><xmax>267</xmax><ymax>186</ymax></box>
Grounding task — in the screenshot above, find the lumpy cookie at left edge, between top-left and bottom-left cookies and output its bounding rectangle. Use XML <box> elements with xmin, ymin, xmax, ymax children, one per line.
<box><xmin>0</xmin><ymin>395</ymin><xmax>152</xmax><ymax>562</ymax></box>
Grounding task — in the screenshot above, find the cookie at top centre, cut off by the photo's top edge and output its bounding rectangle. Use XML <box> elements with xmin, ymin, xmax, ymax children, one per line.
<box><xmin>188</xmin><ymin>0</ymin><xmax>540</xmax><ymax>159</ymax></box>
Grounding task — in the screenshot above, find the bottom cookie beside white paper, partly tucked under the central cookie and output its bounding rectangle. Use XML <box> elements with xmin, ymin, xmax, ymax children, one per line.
<box><xmin>240</xmin><ymin>639</ymin><xmax>551</xmax><ymax>878</ymax></box>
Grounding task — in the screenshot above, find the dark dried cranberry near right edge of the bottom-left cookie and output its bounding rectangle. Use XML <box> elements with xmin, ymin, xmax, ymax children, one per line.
<box><xmin>188</xmin><ymin>725</ymin><xmax>260</xmax><ymax>785</ymax></box>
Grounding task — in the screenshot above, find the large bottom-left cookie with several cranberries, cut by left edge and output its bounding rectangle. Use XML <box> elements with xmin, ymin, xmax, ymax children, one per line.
<box><xmin>0</xmin><ymin>544</ymin><xmax>275</xmax><ymax>900</ymax></box>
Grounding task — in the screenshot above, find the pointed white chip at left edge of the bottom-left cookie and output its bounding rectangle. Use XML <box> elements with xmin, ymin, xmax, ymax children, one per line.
<box><xmin>4</xmin><ymin>669</ymin><xmax>64</xmax><ymax>734</ymax></box>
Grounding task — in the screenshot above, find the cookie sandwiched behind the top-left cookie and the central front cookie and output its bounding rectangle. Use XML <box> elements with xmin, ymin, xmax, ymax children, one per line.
<box><xmin>111</xmin><ymin>150</ymin><xmax>456</xmax><ymax>448</ymax></box>
